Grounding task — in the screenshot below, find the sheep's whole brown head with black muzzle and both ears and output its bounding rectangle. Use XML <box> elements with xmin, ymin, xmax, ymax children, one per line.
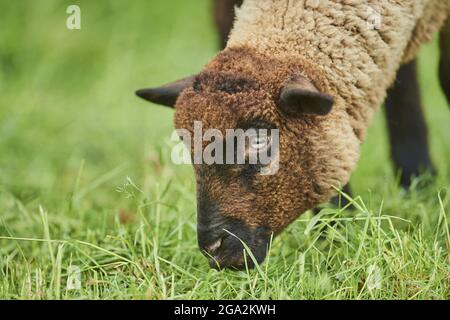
<box><xmin>137</xmin><ymin>49</ymin><xmax>358</xmax><ymax>269</ymax></box>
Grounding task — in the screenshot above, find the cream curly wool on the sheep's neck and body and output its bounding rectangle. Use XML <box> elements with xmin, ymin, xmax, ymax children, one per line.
<box><xmin>227</xmin><ymin>0</ymin><xmax>450</xmax><ymax>141</ymax></box>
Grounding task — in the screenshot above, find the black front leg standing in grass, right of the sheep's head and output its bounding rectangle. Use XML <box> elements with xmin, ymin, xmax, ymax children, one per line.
<box><xmin>386</xmin><ymin>61</ymin><xmax>434</xmax><ymax>187</ymax></box>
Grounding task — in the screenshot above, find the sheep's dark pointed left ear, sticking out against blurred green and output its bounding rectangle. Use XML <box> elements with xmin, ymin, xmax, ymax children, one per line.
<box><xmin>136</xmin><ymin>76</ymin><xmax>195</xmax><ymax>108</ymax></box>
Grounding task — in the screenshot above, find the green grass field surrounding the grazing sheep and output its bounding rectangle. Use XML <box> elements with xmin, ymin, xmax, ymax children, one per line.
<box><xmin>0</xmin><ymin>0</ymin><xmax>450</xmax><ymax>299</ymax></box>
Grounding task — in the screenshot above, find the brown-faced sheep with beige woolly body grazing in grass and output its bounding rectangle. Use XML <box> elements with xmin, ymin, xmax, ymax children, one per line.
<box><xmin>136</xmin><ymin>0</ymin><xmax>450</xmax><ymax>269</ymax></box>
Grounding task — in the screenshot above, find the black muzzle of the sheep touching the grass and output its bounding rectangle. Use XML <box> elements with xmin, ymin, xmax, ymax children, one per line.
<box><xmin>197</xmin><ymin>221</ymin><xmax>270</xmax><ymax>269</ymax></box>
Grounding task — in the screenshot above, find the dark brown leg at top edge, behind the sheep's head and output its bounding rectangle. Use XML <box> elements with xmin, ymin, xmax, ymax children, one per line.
<box><xmin>214</xmin><ymin>0</ymin><xmax>244</xmax><ymax>49</ymax></box>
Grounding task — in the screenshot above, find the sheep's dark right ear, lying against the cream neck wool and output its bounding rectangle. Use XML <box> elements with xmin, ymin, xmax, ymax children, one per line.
<box><xmin>279</xmin><ymin>77</ymin><xmax>334</xmax><ymax>116</ymax></box>
